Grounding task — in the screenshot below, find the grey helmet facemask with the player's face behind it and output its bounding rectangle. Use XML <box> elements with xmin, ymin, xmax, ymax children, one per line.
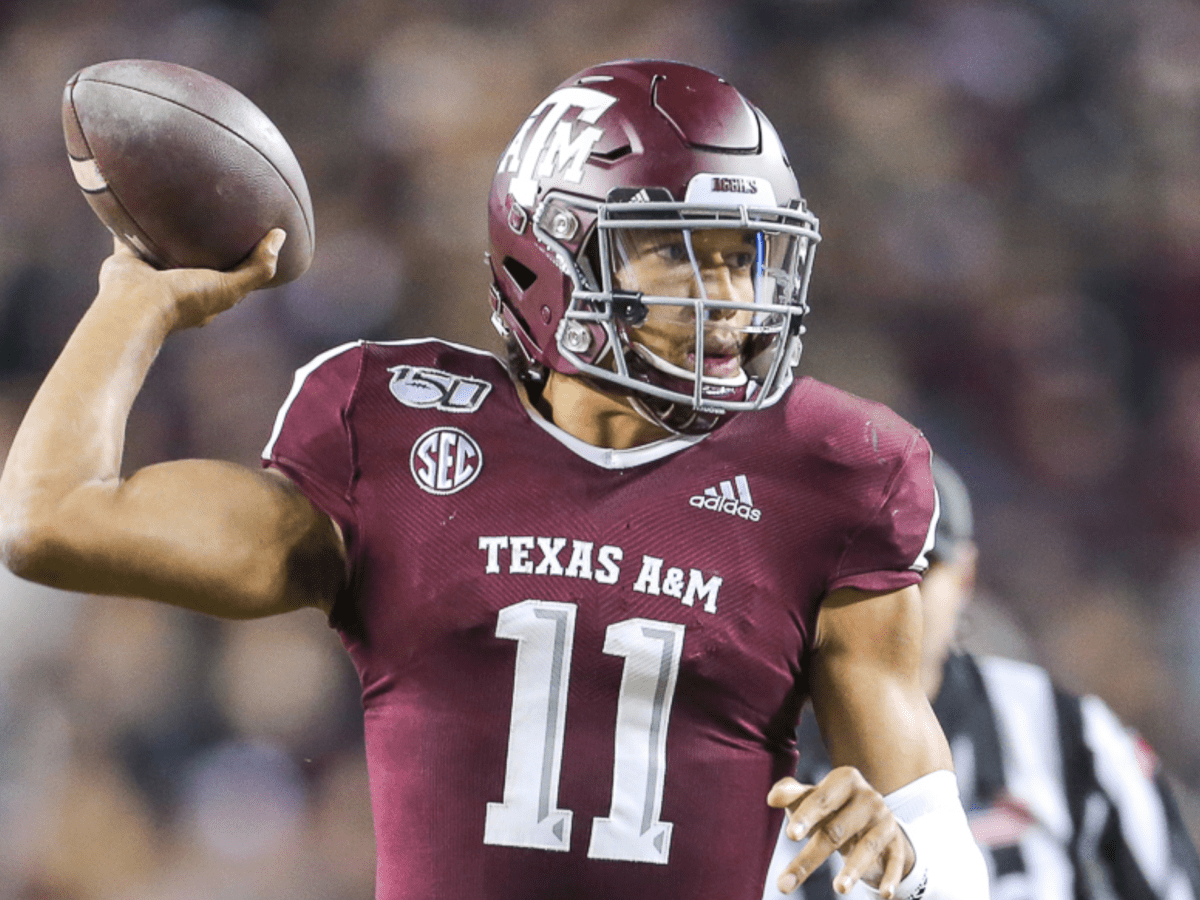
<box><xmin>547</xmin><ymin>175</ymin><xmax>820</xmax><ymax>433</ymax></box>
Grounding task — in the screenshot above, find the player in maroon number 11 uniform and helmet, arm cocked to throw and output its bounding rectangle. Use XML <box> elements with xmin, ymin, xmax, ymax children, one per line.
<box><xmin>0</xmin><ymin>60</ymin><xmax>986</xmax><ymax>900</ymax></box>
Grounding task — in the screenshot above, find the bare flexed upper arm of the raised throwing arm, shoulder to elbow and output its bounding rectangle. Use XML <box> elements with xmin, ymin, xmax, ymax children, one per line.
<box><xmin>22</xmin><ymin>460</ymin><xmax>344</xmax><ymax>618</ymax></box>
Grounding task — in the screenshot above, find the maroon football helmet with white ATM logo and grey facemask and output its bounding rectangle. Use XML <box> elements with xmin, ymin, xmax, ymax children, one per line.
<box><xmin>488</xmin><ymin>60</ymin><xmax>820</xmax><ymax>432</ymax></box>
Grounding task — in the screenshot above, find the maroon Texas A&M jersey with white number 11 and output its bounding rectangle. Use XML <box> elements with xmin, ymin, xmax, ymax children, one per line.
<box><xmin>264</xmin><ymin>341</ymin><xmax>935</xmax><ymax>900</ymax></box>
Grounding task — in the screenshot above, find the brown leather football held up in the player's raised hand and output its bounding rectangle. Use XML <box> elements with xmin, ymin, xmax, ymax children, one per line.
<box><xmin>62</xmin><ymin>60</ymin><xmax>314</xmax><ymax>287</ymax></box>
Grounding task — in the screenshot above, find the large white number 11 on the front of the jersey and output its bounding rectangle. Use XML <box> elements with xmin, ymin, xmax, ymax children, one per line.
<box><xmin>484</xmin><ymin>600</ymin><xmax>684</xmax><ymax>864</ymax></box>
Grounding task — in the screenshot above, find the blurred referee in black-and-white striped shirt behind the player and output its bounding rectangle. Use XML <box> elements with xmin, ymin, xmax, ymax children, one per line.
<box><xmin>763</xmin><ymin>460</ymin><xmax>1200</xmax><ymax>900</ymax></box>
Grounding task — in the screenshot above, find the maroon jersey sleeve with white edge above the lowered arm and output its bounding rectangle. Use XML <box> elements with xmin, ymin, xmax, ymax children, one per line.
<box><xmin>829</xmin><ymin>432</ymin><xmax>937</xmax><ymax>600</ymax></box>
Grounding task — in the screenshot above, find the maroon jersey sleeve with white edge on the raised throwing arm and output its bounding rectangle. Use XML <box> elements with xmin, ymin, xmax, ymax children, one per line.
<box><xmin>263</xmin><ymin>343</ymin><xmax>364</xmax><ymax>535</ymax></box>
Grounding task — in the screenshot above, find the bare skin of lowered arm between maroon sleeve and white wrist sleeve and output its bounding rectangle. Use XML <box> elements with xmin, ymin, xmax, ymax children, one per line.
<box><xmin>810</xmin><ymin>587</ymin><xmax>953</xmax><ymax>793</ymax></box>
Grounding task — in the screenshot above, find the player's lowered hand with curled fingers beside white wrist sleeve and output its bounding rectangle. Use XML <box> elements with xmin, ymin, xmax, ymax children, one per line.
<box><xmin>767</xmin><ymin>766</ymin><xmax>916</xmax><ymax>898</ymax></box>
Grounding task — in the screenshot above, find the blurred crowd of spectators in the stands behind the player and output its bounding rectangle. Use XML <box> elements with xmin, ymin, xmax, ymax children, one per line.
<box><xmin>0</xmin><ymin>0</ymin><xmax>1200</xmax><ymax>900</ymax></box>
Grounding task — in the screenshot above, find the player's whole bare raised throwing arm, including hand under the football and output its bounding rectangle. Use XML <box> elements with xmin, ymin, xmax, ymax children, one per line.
<box><xmin>0</xmin><ymin>230</ymin><xmax>344</xmax><ymax>618</ymax></box>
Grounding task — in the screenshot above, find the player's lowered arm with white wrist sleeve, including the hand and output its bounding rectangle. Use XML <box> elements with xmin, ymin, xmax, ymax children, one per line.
<box><xmin>768</xmin><ymin>587</ymin><xmax>988</xmax><ymax>900</ymax></box>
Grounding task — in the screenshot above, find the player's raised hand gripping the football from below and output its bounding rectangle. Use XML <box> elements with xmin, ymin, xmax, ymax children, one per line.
<box><xmin>100</xmin><ymin>228</ymin><xmax>287</xmax><ymax>331</ymax></box>
